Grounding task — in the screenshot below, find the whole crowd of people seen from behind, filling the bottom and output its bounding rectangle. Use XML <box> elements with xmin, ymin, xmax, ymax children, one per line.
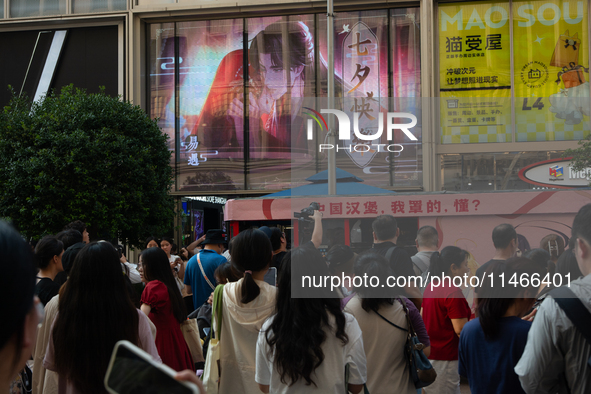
<box><xmin>0</xmin><ymin>204</ymin><xmax>591</xmax><ymax>394</ymax></box>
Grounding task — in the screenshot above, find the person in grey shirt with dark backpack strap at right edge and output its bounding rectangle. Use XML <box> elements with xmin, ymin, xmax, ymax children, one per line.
<box><xmin>515</xmin><ymin>204</ymin><xmax>591</xmax><ymax>394</ymax></box>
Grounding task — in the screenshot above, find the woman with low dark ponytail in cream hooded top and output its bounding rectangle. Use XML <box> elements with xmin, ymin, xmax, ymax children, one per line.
<box><xmin>214</xmin><ymin>229</ymin><xmax>276</xmax><ymax>394</ymax></box>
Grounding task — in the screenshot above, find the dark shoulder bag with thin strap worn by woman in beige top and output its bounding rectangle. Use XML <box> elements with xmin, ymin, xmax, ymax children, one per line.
<box><xmin>374</xmin><ymin>299</ymin><xmax>437</xmax><ymax>389</ymax></box>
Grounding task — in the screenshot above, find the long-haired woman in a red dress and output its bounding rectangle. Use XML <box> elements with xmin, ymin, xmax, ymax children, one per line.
<box><xmin>141</xmin><ymin>248</ymin><xmax>195</xmax><ymax>371</ymax></box>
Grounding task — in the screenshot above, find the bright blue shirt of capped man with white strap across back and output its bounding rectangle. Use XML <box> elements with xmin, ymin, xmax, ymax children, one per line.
<box><xmin>185</xmin><ymin>249</ymin><xmax>227</xmax><ymax>312</ymax></box>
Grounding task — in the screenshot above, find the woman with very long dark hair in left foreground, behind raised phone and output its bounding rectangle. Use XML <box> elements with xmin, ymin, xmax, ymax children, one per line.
<box><xmin>43</xmin><ymin>242</ymin><xmax>160</xmax><ymax>394</ymax></box>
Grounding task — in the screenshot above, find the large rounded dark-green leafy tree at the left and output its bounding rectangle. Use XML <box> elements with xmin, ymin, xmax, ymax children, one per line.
<box><xmin>0</xmin><ymin>86</ymin><xmax>174</xmax><ymax>245</ymax></box>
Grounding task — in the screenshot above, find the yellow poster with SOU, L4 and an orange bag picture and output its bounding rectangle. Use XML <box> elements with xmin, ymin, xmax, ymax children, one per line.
<box><xmin>513</xmin><ymin>0</ymin><xmax>590</xmax><ymax>141</ymax></box>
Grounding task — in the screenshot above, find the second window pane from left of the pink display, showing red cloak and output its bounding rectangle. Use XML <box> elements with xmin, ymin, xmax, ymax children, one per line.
<box><xmin>177</xmin><ymin>19</ymin><xmax>244</xmax><ymax>191</ymax></box>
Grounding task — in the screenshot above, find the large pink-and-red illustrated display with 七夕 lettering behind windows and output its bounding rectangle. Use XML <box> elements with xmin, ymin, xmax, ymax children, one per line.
<box><xmin>150</xmin><ymin>8</ymin><xmax>422</xmax><ymax>191</ymax></box>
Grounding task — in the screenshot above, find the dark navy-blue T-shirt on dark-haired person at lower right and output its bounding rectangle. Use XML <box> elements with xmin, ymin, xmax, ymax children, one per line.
<box><xmin>458</xmin><ymin>316</ymin><xmax>531</xmax><ymax>394</ymax></box>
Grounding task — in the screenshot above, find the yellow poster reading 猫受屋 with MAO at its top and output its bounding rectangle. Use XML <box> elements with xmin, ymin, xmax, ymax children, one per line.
<box><xmin>439</xmin><ymin>3</ymin><xmax>512</xmax><ymax>144</ymax></box>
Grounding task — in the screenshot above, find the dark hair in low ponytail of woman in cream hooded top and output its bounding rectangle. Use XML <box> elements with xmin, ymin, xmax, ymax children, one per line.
<box><xmin>231</xmin><ymin>229</ymin><xmax>273</xmax><ymax>304</ymax></box>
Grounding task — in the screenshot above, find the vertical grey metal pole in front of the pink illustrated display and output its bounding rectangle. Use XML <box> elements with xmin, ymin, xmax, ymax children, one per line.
<box><xmin>326</xmin><ymin>0</ymin><xmax>337</xmax><ymax>196</ymax></box>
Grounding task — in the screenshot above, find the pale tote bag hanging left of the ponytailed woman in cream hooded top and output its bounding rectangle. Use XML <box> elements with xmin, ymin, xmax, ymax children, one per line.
<box><xmin>203</xmin><ymin>285</ymin><xmax>224</xmax><ymax>394</ymax></box>
